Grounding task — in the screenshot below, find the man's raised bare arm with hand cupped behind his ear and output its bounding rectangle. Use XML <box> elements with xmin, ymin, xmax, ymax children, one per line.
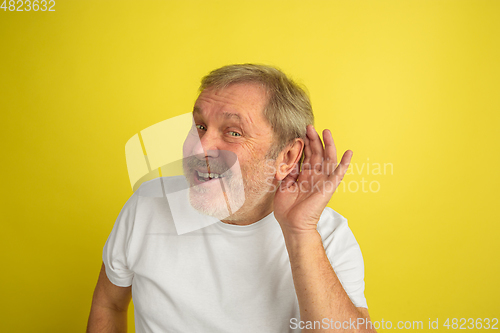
<box><xmin>274</xmin><ymin>125</ymin><xmax>375</xmax><ymax>332</ymax></box>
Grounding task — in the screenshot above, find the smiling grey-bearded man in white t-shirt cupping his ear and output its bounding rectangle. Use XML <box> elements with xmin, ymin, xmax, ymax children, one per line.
<box><xmin>87</xmin><ymin>64</ymin><xmax>373</xmax><ymax>333</ymax></box>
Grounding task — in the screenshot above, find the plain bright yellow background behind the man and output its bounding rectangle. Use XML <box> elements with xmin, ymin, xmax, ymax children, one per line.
<box><xmin>0</xmin><ymin>0</ymin><xmax>500</xmax><ymax>332</ymax></box>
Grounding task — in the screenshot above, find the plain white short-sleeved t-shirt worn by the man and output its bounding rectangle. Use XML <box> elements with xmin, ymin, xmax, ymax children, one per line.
<box><xmin>103</xmin><ymin>176</ymin><xmax>367</xmax><ymax>333</ymax></box>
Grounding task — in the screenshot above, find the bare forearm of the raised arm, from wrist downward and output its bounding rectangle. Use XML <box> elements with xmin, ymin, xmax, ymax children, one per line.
<box><xmin>284</xmin><ymin>231</ymin><xmax>372</xmax><ymax>332</ymax></box>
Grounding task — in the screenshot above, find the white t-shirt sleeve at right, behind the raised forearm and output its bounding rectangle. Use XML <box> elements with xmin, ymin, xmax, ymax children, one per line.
<box><xmin>318</xmin><ymin>207</ymin><xmax>368</xmax><ymax>308</ymax></box>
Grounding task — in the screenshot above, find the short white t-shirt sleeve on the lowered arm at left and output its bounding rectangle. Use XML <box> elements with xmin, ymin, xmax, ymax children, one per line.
<box><xmin>102</xmin><ymin>193</ymin><xmax>138</xmax><ymax>287</ymax></box>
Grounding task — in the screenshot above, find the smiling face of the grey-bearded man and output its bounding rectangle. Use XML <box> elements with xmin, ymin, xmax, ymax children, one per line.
<box><xmin>183</xmin><ymin>83</ymin><xmax>274</xmax><ymax>221</ymax></box>
